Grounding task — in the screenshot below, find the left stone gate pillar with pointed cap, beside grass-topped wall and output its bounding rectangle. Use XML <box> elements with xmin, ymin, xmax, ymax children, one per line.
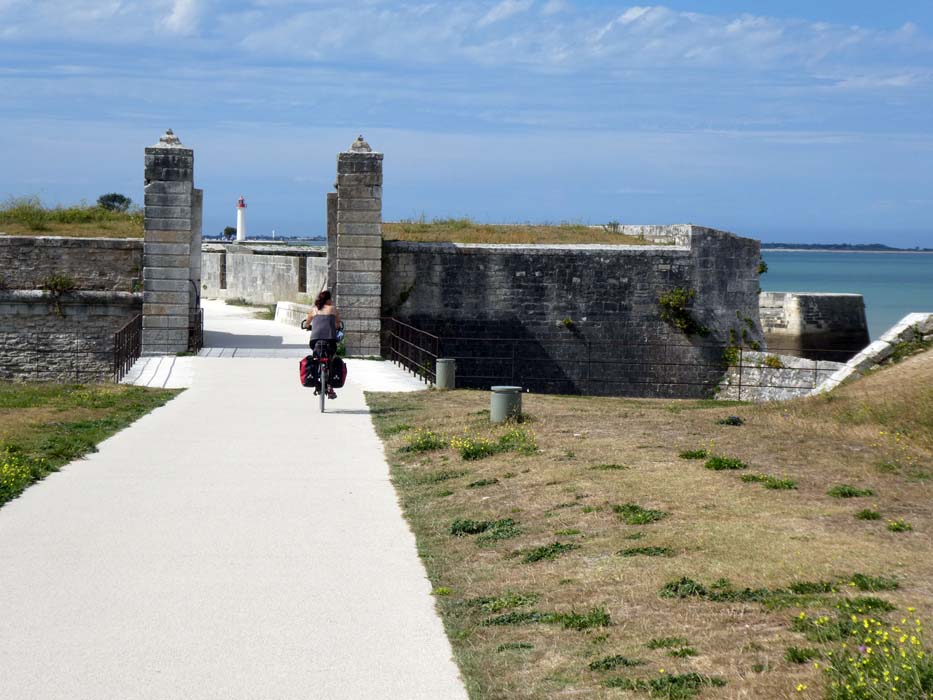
<box><xmin>142</xmin><ymin>129</ymin><xmax>201</xmax><ymax>355</ymax></box>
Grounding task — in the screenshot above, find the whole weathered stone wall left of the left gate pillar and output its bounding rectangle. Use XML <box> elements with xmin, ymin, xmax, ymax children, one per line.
<box><xmin>0</xmin><ymin>236</ymin><xmax>143</xmax><ymax>382</ymax></box>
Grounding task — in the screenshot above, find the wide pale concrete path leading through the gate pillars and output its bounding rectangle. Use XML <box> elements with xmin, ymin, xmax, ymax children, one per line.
<box><xmin>0</xmin><ymin>305</ymin><xmax>466</xmax><ymax>700</ymax></box>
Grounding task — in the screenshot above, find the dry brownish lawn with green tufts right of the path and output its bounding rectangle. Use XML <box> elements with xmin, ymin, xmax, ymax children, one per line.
<box><xmin>368</xmin><ymin>353</ymin><xmax>933</xmax><ymax>700</ymax></box>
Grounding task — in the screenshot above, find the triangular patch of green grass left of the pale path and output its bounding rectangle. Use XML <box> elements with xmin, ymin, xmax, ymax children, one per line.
<box><xmin>0</xmin><ymin>382</ymin><xmax>178</xmax><ymax>505</ymax></box>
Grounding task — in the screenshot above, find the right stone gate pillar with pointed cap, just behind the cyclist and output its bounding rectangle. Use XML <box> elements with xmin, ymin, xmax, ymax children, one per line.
<box><xmin>337</xmin><ymin>136</ymin><xmax>383</xmax><ymax>356</ymax></box>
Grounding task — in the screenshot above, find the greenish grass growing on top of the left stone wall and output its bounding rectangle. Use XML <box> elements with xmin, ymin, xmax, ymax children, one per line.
<box><xmin>0</xmin><ymin>196</ymin><xmax>143</xmax><ymax>238</ymax></box>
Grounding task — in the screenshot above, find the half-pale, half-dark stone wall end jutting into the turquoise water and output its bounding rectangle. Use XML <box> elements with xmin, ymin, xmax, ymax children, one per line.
<box><xmin>759</xmin><ymin>292</ymin><xmax>870</xmax><ymax>362</ymax></box>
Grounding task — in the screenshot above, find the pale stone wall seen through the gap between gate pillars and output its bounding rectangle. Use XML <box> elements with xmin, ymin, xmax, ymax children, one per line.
<box><xmin>201</xmin><ymin>245</ymin><xmax>327</xmax><ymax>304</ymax></box>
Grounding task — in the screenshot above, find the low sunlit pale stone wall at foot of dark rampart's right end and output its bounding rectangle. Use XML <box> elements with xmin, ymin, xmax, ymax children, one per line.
<box><xmin>716</xmin><ymin>351</ymin><xmax>845</xmax><ymax>402</ymax></box>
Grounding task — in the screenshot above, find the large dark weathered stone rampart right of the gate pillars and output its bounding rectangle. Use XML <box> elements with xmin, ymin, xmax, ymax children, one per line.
<box><xmin>382</xmin><ymin>226</ymin><xmax>762</xmax><ymax>397</ymax></box>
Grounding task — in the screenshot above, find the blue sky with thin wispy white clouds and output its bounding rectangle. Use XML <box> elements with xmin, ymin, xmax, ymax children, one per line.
<box><xmin>0</xmin><ymin>0</ymin><xmax>933</xmax><ymax>247</ymax></box>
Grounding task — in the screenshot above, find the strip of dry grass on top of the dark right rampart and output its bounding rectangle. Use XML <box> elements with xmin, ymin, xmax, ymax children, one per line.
<box><xmin>382</xmin><ymin>218</ymin><xmax>648</xmax><ymax>245</ymax></box>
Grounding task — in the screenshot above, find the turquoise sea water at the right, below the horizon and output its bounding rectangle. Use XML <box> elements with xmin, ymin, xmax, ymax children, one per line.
<box><xmin>761</xmin><ymin>250</ymin><xmax>933</xmax><ymax>339</ymax></box>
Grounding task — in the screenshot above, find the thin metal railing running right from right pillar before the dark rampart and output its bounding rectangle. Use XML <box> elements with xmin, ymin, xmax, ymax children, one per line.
<box><xmin>383</xmin><ymin>318</ymin><xmax>840</xmax><ymax>400</ymax></box>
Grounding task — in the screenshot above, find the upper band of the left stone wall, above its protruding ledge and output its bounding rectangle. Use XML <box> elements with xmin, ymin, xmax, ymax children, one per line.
<box><xmin>0</xmin><ymin>236</ymin><xmax>143</xmax><ymax>292</ymax></box>
